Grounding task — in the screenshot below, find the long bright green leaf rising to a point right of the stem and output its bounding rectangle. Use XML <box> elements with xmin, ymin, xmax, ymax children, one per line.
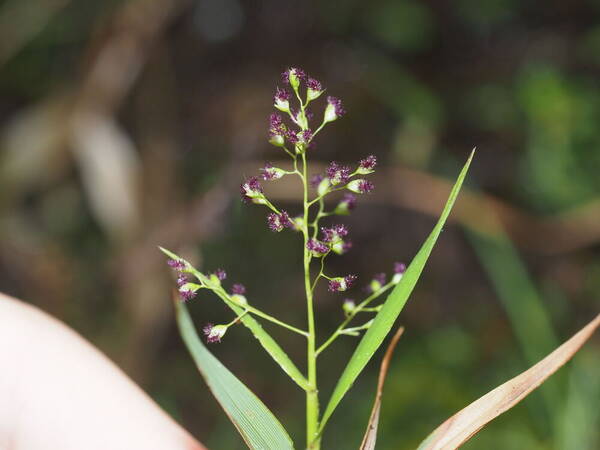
<box><xmin>319</xmin><ymin>150</ymin><xmax>475</xmax><ymax>432</ymax></box>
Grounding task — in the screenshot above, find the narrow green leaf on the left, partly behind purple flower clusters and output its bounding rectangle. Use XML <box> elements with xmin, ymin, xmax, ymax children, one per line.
<box><xmin>159</xmin><ymin>247</ymin><xmax>309</xmax><ymax>390</ymax></box>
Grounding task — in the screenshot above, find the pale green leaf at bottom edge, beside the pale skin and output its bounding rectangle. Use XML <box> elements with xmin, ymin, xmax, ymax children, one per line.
<box><xmin>175</xmin><ymin>300</ymin><xmax>294</xmax><ymax>450</ymax></box>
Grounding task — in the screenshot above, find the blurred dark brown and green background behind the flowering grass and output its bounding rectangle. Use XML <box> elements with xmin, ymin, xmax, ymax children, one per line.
<box><xmin>0</xmin><ymin>0</ymin><xmax>600</xmax><ymax>450</ymax></box>
